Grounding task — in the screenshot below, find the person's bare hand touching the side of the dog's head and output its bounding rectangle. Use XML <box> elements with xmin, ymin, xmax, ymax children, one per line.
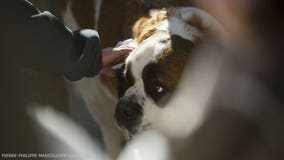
<box><xmin>100</xmin><ymin>47</ymin><xmax>133</xmax><ymax>77</ymax></box>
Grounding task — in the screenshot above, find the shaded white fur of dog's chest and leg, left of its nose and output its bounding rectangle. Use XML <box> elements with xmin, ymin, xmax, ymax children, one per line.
<box><xmin>74</xmin><ymin>76</ymin><xmax>125</xmax><ymax>158</ymax></box>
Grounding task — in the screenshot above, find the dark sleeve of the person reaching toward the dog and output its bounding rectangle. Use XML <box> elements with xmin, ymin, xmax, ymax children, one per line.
<box><xmin>0</xmin><ymin>0</ymin><xmax>102</xmax><ymax>80</ymax></box>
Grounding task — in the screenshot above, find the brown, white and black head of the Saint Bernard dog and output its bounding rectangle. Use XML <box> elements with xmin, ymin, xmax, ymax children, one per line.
<box><xmin>115</xmin><ymin>8</ymin><xmax>224</xmax><ymax>134</ymax></box>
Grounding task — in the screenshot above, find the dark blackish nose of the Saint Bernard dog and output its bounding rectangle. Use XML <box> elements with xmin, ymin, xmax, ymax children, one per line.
<box><xmin>115</xmin><ymin>97</ymin><xmax>142</xmax><ymax>133</ymax></box>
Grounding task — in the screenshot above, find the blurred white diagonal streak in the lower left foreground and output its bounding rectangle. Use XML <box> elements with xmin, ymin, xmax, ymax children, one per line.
<box><xmin>28</xmin><ymin>105</ymin><xmax>108</xmax><ymax>160</ymax></box>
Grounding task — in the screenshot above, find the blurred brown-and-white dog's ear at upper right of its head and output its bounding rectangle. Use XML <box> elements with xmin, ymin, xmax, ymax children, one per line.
<box><xmin>170</xmin><ymin>7</ymin><xmax>226</xmax><ymax>37</ymax></box>
